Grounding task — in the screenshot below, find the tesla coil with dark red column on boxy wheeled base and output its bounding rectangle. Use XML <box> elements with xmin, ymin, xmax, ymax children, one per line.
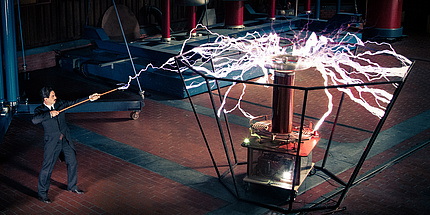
<box><xmin>242</xmin><ymin>55</ymin><xmax>320</xmax><ymax>191</ymax></box>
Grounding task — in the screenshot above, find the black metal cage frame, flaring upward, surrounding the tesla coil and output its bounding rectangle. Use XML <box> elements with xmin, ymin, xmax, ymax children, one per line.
<box><xmin>175</xmin><ymin>47</ymin><xmax>415</xmax><ymax>213</ymax></box>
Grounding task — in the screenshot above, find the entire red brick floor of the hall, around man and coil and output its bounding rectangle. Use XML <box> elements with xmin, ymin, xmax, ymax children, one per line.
<box><xmin>0</xmin><ymin>31</ymin><xmax>430</xmax><ymax>214</ymax></box>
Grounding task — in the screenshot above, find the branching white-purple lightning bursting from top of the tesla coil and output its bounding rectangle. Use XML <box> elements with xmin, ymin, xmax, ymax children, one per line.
<box><xmin>120</xmin><ymin>25</ymin><xmax>412</xmax><ymax>131</ymax></box>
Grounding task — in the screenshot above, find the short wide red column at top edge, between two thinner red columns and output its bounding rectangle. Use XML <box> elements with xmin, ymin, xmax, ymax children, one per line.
<box><xmin>225</xmin><ymin>0</ymin><xmax>244</xmax><ymax>28</ymax></box>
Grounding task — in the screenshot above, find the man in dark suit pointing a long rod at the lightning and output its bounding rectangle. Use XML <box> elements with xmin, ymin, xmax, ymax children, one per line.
<box><xmin>32</xmin><ymin>87</ymin><xmax>100</xmax><ymax>203</ymax></box>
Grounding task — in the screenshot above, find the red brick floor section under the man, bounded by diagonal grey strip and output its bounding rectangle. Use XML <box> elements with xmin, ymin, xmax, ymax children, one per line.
<box><xmin>0</xmin><ymin>118</ymin><xmax>225</xmax><ymax>214</ymax></box>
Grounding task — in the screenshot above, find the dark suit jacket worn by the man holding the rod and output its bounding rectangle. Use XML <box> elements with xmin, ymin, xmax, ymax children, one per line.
<box><xmin>32</xmin><ymin>98</ymin><xmax>86</xmax><ymax>153</ymax></box>
